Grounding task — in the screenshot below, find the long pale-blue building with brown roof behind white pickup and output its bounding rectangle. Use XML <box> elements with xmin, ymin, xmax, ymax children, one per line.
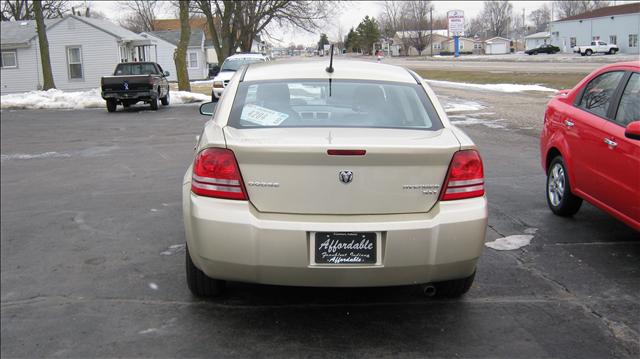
<box><xmin>550</xmin><ymin>3</ymin><xmax>640</xmax><ymax>54</ymax></box>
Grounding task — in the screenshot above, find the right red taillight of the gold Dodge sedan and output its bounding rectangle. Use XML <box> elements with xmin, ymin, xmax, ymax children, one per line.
<box><xmin>440</xmin><ymin>150</ymin><xmax>484</xmax><ymax>201</ymax></box>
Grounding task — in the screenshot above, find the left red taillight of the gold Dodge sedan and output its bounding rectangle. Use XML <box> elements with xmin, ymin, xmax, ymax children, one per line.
<box><xmin>191</xmin><ymin>148</ymin><xmax>247</xmax><ymax>200</ymax></box>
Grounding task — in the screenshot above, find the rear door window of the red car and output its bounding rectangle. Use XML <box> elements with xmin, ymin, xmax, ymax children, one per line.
<box><xmin>578</xmin><ymin>71</ymin><xmax>624</xmax><ymax>117</ymax></box>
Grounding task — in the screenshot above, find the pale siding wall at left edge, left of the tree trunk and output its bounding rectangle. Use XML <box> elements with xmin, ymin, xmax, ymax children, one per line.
<box><xmin>0</xmin><ymin>42</ymin><xmax>42</xmax><ymax>94</ymax></box>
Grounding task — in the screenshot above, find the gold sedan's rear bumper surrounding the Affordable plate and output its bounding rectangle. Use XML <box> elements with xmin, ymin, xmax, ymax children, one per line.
<box><xmin>183</xmin><ymin>183</ymin><xmax>487</xmax><ymax>287</ymax></box>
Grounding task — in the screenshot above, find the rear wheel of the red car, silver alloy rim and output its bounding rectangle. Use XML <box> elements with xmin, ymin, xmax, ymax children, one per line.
<box><xmin>547</xmin><ymin>156</ymin><xmax>582</xmax><ymax>217</ymax></box>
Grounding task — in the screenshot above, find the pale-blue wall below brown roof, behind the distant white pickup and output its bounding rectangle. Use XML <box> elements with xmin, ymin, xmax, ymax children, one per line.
<box><xmin>551</xmin><ymin>14</ymin><xmax>640</xmax><ymax>54</ymax></box>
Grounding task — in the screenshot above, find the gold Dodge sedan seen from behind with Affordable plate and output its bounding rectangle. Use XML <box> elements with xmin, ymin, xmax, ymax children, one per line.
<box><xmin>182</xmin><ymin>59</ymin><xmax>487</xmax><ymax>297</ymax></box>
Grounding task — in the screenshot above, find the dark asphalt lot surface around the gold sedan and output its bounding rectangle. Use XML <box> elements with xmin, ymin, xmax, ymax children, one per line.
<box><xmin>0</xmin><ymin>102</ymin><xmax>640</xmax><ymax>358</ymax></box>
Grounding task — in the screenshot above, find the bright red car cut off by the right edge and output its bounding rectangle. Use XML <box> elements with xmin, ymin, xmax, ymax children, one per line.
<box><xmin>540</xmin><ymin>61</ymin><xmax>640</xmax><ymax>231</ymax></box>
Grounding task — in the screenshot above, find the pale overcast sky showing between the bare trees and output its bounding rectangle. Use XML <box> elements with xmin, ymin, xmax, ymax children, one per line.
<box><xmin>87</xmin><ymin>1</ymin><xmax>631</xmax><ymax>46</ymax></box>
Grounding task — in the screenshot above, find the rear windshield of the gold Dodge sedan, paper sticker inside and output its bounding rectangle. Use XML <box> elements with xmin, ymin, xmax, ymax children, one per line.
<box><xmin>228</xmin><ymin>80</ymin><xmax>442</xmax><ymax>130</ymax></box>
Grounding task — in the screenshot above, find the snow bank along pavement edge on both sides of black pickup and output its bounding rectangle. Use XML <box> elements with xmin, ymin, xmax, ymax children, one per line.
<box><xmin>0</xmin><ymin>88</ymin><xmax>209</xmax><ymax>110</ymax></box>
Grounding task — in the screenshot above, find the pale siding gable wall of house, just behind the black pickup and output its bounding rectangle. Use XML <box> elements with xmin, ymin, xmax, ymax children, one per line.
<box><xmin>46</xmin><ymin>17</ymin><xmax>120</xmax><ymax>90</ymax></box>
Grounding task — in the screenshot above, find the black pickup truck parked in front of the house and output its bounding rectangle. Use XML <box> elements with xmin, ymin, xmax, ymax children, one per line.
<box><xmin>100</xmin><ymin>62</ymin><xmax>169</xmax><ymax>112</ymax></box>
